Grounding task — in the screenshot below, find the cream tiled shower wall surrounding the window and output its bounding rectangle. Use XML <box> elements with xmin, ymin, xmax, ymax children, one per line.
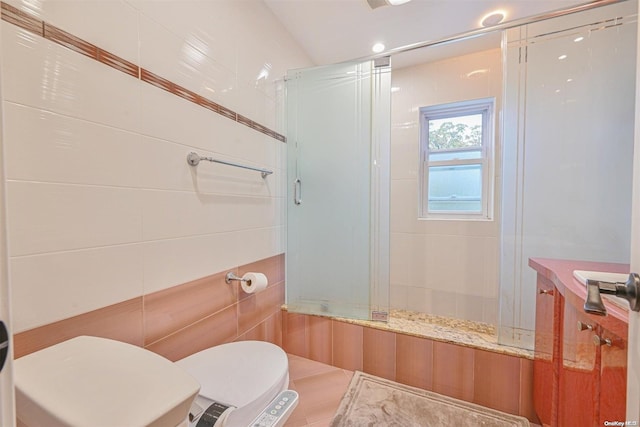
<box><xmin>390</xmin><ymin>49</ymin><xmax>502</xmax><ymax>324</ymax></box>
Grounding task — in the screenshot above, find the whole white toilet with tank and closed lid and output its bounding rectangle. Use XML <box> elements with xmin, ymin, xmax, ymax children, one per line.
<box><xmin>14</xmin><ymin>336</ymin><xmax>298</xmax><ymax>427</ymax></box>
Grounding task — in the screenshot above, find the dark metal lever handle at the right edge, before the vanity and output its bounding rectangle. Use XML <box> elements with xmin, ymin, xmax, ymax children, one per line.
<box><xmin>584</xmin><ymin>273</ymin><xmax>640</xmax><ymax>316</ymax></box>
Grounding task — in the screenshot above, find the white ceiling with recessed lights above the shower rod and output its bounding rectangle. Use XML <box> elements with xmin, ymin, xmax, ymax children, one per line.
<box><xmin>264</xmin><ymin>0</ymin><xmax>589</xmax><ymax>67</ymax></box>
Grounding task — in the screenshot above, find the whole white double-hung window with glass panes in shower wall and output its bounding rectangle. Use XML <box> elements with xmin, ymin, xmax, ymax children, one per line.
<box><xmin>420</xmin><ymin>98</ymin><xmax>494</xmax><ymax>219</ymax></box>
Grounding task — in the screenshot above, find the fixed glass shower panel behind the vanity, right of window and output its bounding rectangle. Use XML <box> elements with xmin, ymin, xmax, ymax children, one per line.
<box><xmin>499</xmin><ymin>2</ymin><xmax>637</xmax><ymax>348</ymax></box>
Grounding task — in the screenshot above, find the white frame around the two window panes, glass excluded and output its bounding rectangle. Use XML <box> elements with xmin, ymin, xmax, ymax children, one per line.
<box><xmin>418</xmin><ymin>97</ymin><xmax>495</xmax><ymax>221</ymax></box>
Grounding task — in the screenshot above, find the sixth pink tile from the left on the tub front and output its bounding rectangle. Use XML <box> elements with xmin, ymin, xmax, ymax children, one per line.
<box><xmin>433</xmin><ymin>341</ymin><xmax>474</xmax><ymax>402</ymax></box>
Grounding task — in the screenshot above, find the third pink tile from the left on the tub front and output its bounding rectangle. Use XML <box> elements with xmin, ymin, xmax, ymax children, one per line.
<box><xmin>333</xmin><ymin>320</ymin><xmax>364</xmax><ymax>371</ymax></box>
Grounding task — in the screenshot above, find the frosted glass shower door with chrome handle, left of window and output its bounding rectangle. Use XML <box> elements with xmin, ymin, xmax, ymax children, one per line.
<box><xmin>286</xmin><ymin>61</ymin><xmax>391</xmax><ymax>320</ymax></box>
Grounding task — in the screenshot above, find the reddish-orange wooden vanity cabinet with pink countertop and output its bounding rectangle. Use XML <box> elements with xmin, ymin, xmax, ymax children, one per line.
<box><xmin>529</xmin><ymin>259</ymin><xmax>628</xmax><ymax>427</ymax></box>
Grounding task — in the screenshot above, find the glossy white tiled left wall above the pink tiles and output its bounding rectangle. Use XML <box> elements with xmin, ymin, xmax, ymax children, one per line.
<box><xmin>1</xmin><ymin>0</ymin><xmax>312</xmax><ymax>332</ymax></box>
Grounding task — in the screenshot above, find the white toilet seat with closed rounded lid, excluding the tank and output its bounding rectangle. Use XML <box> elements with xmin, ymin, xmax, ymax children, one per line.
<box><xmin>175</xmin><ymin>341</ymin><xmax>289</xmax><ymax>427</ymax></box>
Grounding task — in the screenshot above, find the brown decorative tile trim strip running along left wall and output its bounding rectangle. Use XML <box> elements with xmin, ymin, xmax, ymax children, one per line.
<box><xmin>0</xmin><ymin>1</ymin><xmax>287</xmax><ymax>142</ymax></box>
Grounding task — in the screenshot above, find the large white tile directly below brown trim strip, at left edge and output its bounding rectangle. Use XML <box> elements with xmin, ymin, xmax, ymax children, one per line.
<box><xmin>2</xmin><ymin>21</ymin><xmax>140</xmax><ymax>131</ymax></box>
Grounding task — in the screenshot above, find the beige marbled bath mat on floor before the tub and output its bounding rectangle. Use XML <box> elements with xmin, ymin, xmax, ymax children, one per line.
<box><xmin>330</xmin><ymin>371</ymin><xmax>529</xmax><ymax>427</ymax></box>
